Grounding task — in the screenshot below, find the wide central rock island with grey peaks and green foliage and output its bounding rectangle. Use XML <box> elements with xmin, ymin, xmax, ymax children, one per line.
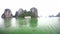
<box><xmin>15</xmin><ymin>7</ymin><xmax>38</xmax><ymax>17</ymax></box>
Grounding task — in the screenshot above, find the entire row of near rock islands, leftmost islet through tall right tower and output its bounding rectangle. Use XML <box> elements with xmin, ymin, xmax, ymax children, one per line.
<box><xmin>1</xmin><ymin>7</ymin><xmax>38</xmax><ymax>18</ymax></box>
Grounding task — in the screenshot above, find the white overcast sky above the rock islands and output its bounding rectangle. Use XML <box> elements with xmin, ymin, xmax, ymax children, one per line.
<box><xmin>0</xmin><ymin>0</ymin><xmax>60</xmax><ymax>16</ymax></box>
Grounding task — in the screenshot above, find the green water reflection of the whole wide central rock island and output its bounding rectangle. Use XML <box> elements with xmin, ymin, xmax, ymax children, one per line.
<box><xmin>16</xmin><ymin>18</ymin><xmax>37</xmax><ymax>27</ymax></box>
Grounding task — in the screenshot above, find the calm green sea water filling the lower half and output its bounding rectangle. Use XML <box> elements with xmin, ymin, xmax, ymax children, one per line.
<box><xmin>0</xmin><ymin>17</ymin><xmax>60</xmax><ymax>34</ymax></box>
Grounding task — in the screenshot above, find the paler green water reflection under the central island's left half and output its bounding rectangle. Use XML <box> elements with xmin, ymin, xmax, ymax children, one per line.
<box><xmin>16</xmin><ymin>18</ymin><xmax>29</xmax><ymax>27</ymax></box>
